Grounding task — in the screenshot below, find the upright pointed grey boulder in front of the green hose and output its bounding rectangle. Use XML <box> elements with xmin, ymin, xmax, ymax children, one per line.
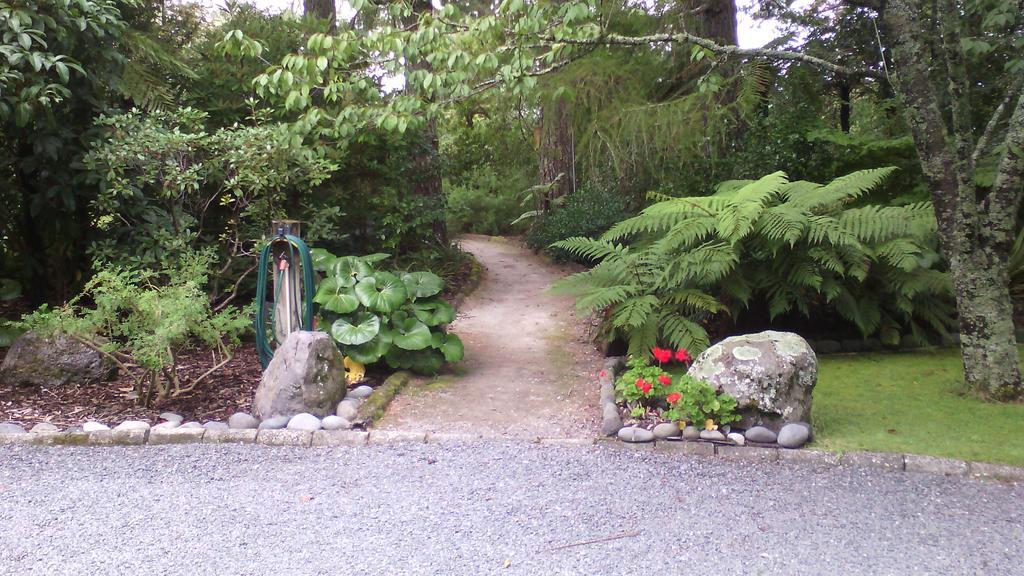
<box><xmin>252</xmin><ymin>331</ymin><xmax>345</xmax><ymax>419</ymax></box>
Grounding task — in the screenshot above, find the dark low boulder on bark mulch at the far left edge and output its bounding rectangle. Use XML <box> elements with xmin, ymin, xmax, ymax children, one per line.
<box><xmin>0</xmin><ymin>332</ymin><xmax>117</xmax><ymax>387</ymax></box>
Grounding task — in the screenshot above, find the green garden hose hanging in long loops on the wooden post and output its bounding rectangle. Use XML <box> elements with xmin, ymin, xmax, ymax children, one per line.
<box><xmin>253</xmin><ymin>234</ymin><xmax>313</xmax><ymax>368</ymax></box>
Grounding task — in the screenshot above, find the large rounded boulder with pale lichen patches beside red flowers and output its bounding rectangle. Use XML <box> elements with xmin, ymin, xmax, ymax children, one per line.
<box><xmin>687</xmin><ymin>330</ymin><xmax>818</xmax><ymax>429</ymax></box>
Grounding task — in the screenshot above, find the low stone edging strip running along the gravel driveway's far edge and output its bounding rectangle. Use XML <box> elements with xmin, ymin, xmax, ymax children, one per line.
<box><xmin>0</xmin><ymin>427</ymin><xmax>1024</xmax><ymax>483</ymax></box>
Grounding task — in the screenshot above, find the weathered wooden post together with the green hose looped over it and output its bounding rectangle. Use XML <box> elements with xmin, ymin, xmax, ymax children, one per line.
<box><xmin>253</xmin><ymin>230</ymin><xmax>314</xmax><ymax>368</ymax></box>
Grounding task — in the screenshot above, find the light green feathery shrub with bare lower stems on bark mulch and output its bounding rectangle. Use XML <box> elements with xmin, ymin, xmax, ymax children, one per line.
<box><xmin>23</xmin><ymin>253</ymin><xmax>250</xmax><ymax>406</ymax></box>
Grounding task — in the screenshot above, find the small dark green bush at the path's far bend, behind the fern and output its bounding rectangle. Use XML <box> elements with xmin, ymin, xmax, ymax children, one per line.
<box><xmin>526</xmin><ymin>186</ymin><xmax>633</xmax><ymax>261</ymax></box>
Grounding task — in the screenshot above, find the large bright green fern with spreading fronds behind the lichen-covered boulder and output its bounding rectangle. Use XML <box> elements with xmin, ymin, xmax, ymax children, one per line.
<box><xmin>555</xmin><ymin>168</ymin><xmax>952</xmax><ymax>356</ymax></box>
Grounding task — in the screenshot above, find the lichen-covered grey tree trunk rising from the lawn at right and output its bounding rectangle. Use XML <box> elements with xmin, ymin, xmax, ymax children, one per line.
<box><xmin>883</xmin><ymin>0</ymin><xmax>1024</xmax><ymax>400</ymax></box>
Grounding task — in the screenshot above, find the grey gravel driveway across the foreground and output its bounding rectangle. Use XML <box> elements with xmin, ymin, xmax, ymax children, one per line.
<box><xmin>0</xmin><ymin>443</ymin><xmax>1024</xmax><ymax>576</ymax></box>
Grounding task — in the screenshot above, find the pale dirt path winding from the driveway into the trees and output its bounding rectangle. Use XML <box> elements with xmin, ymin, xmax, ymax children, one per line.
<box><xmin>377</xmin><ymin>236</ymin><xmax>601</xmax><ymax>438</ymax></box>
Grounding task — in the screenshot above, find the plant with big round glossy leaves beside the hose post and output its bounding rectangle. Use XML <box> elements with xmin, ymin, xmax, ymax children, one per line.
<box><xmin>313</xmin><ymin>249</ymin><xmax>464</xmax><ymax>374</ymax></box>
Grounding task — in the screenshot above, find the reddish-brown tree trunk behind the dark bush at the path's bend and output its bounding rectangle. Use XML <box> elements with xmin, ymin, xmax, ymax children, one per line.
<box><xmin>538</xmin><ymin>98</ymin><xmax>575</xmax><ymax>210</ymax></box>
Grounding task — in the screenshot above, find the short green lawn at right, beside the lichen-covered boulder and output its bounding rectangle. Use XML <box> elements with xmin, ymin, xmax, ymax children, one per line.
<box><xmin>813</xmin><ymin>349</ymin><xmax>1024</xmax><ymax>465</ymax></box>
